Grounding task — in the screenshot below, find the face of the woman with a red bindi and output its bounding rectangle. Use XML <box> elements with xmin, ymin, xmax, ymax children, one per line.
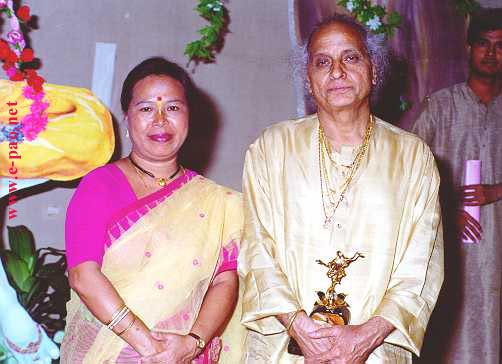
<box><xmin>126</xmin><ymin>75</ymin><xmax>189</xmax><ymax>162</ymax></box>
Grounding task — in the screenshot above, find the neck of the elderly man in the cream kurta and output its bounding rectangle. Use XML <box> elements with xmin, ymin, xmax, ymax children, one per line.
<box><xmin>318</xmin><ymin>106</ymin><xmax>370</xmax><ymax>151</ymax></box>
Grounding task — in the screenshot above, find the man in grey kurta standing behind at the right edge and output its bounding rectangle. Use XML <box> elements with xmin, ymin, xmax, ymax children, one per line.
<box><xmin>413</xmin><ymin>9</ymin><xmax>502</xmax><ymax>364</ymax></box>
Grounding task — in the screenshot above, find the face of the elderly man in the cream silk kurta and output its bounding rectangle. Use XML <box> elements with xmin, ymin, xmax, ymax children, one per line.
<box><xmin>307</xmin><ymin>23</ymin><xmax>374</xmax><ymax>112</ymax></box>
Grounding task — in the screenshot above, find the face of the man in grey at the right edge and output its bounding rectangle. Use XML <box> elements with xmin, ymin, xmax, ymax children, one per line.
<box><xmin>470</xmin><ymin>29</ymin><xmax>502</xmax><ymax>77</ymax></box>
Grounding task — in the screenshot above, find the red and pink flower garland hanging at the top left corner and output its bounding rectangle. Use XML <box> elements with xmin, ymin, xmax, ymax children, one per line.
<box><xmin>0</xmin><ymin>0</ymin><xmax>49</xmax><ymax>142</ymax></box>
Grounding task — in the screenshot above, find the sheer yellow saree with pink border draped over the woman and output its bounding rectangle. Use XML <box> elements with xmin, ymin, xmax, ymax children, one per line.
<box><xmin>61</xmin><ymin>171</ymin><xmax>244</xmax><ymax>364</ymax></box>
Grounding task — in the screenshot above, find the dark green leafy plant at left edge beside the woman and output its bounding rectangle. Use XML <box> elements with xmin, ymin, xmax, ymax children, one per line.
<box><xmin>0</xmin><ymin>225</ymin><xmax>70</xmax><ymax>336</ymax></box>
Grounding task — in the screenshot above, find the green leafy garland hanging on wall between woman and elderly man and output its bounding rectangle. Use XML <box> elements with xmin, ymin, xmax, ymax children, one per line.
<box><xmin>184</xmin><ymin>0</ymin><xmax>227</xmax><ymax>63</ymax></box>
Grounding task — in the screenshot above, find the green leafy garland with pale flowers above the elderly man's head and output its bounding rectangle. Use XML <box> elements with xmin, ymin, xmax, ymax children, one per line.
<box><xmin>338</xmin><ymin>0</ymin><xmax>401</xmax><ymax>36</ymax></box>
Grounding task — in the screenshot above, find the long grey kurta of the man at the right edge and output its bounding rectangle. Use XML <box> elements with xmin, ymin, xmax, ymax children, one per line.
<box><xmin>413</xmin><ymin>82</ymin><xmax>502</xmax><ymax>364</ymax></box>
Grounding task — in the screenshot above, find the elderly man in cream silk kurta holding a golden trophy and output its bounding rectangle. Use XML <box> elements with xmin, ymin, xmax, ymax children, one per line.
<box><xmin>239</xmin><ymin>15</ymin><xmax>443</xmax><ymax>363</ymax></box>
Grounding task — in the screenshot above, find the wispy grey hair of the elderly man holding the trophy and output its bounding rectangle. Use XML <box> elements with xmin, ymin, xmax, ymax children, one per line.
<box><xmin>291</xmin><ymin>14</ymin><xmax>390</xmax><ymax>105</ymax></box>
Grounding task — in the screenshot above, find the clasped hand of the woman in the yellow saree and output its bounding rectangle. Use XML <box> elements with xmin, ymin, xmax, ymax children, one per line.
<box><xmin>140</xmin><ymin>331</ymin><xmax>200</xmax><ymax>364</ymax></box>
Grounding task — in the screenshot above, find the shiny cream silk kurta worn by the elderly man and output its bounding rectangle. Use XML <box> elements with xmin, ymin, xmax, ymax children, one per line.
<box><xmin>239</xmin><ymin>115</ymin><xmax>443</xmax><ymax>363</ymax></box>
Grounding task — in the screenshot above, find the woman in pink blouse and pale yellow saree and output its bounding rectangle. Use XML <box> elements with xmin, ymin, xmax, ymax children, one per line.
<box><xmin>61</xmin><ymin>58</ymin><xmax>242</xmax><ymax>364</ymax></box>
